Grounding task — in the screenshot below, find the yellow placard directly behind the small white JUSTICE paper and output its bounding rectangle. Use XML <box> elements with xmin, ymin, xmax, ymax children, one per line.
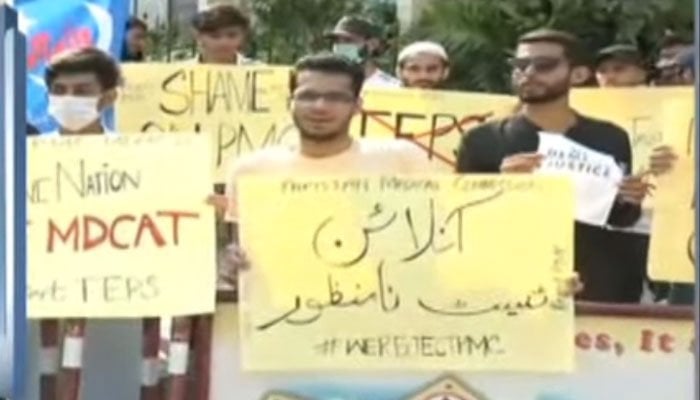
<box><xmin>571</xmin><ymin>86</ymin><xmax>694</xmax><ymax>173</ymax></box>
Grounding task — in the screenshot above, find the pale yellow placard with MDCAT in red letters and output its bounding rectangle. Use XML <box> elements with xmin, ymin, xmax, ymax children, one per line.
<box><xmin>27</xmin><ymin>134</ymin><xmax>215</xmax><ymax>318</ymax></box>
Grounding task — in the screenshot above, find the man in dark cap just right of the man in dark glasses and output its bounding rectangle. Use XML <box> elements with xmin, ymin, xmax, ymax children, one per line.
<box><xmin>595</xmin><ymin>44</ymin><xmax>647</xmax><ymax>87</ymax></box>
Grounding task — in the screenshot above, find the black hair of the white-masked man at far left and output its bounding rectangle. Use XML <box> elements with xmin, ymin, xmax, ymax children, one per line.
<box><xmin>44</xmin><ymin>47</ymin><xmax>122</xmax><ymax>90</ymax></box>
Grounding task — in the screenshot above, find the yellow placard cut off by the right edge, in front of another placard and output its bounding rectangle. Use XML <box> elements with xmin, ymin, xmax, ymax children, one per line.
<box><xmin>649</xmin><ymin>99</ymin><xmax>697</xmax><ymax>283</ymax></box>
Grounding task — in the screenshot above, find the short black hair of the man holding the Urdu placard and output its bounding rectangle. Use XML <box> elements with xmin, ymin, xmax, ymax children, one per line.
<box><xmin>290</xmin><ymin>52</ymin><xmax>365</xmax><ymax>97</ymax></box>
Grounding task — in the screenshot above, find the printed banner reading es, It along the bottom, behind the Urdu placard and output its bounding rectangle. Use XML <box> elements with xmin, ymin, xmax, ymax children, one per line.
<box><xmin>209</xmin><ymin>304</ymin><xmax>697</xmax><ymax>400</ymax></box>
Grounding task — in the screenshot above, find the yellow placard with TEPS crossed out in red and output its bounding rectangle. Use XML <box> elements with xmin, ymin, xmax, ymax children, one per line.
<box><xmin>352</xmin><ymin>89</ymin><xmax>516</xmax><ymax>171</ymax></box>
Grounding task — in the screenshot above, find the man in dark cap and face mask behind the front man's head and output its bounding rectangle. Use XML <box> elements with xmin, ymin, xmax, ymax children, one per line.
<box><xmin>326</xmin><ymin>16</ymin><xmax>401</xmax><ymax>87</ymax></box>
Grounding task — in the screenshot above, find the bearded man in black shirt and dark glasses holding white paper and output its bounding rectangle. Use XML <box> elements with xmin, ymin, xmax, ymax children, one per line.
<box><xmin>457</xmin><ymin>30</ymin><xmax>648</xmax><ymax>302</ymax></box>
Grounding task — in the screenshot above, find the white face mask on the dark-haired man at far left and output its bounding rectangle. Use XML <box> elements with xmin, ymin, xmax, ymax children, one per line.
<box><xmin>49</xmin><ymin>96</ymin><xmax>100</xmax><ymax>132</ymax></box>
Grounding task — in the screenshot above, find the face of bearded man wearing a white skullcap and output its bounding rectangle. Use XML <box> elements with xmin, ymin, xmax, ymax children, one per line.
<box><xmin>396</xmin><ymin>41</ymin><xmax>450</xmax><ymax>89</ymax></box>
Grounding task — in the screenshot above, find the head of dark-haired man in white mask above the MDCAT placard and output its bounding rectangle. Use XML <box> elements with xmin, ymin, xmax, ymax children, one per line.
<box><xmin>45</xmin><ymin>48</ymin><xmax>121</xmax><ymax>135</ymax></box>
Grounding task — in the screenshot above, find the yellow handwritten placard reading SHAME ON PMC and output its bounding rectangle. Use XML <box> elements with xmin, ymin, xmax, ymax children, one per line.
<box><xmin>116</xmin><ymin>64</ymin><xmax>297</xmax><ymax>183</ymax></box>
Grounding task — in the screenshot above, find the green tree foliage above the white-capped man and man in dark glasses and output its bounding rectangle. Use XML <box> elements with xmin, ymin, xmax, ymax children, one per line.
<box><xmin>401</xmin><ymin>0</ymin><xmax>693</xmax><ymax>92</ymax></box>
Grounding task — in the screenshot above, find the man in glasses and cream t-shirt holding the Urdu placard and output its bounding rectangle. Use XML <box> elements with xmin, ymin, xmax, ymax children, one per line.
<box><xmin>220</xmin><ymin>54</ymin><xmax>434</xmax><ymax>289</ymax></box>
